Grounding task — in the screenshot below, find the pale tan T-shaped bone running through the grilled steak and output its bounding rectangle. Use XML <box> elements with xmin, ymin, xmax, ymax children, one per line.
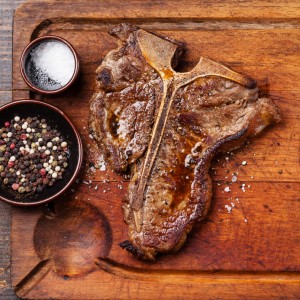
<box><xmin>131</xmin><ymin>29</ymin><xmax>255</xmax><ymax>219</ymax></box>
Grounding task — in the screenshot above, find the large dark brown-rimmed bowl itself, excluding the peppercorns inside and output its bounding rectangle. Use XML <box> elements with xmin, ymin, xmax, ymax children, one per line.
<box><xmin>0</xmin><ymin>100</ymin><xmax>83</xmax><ymax>206</ymax></box>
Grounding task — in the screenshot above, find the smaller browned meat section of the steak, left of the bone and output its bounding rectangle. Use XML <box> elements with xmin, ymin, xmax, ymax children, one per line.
<box><xmin>89</xmin><ymin>24</ymin><xmax>181</xmax><ymax>172</ymax></box>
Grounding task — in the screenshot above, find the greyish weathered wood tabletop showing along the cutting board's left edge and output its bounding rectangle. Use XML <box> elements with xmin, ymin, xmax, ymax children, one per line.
<box><xmin>0</xmin><ymin>0</ymin><xmax>24</xmax><ymax>300</ymax></box>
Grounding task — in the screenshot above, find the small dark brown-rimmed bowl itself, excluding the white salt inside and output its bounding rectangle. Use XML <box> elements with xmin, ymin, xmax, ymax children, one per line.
<box><xmin>20</xmin><ymin>35</ymin><xmax>79</xmax><ymax>95</ymax></box>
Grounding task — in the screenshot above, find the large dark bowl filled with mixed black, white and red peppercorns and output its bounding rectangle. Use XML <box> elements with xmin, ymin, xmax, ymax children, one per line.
<box><xmin>0</xmin><ymin>100</ymin><xmax>83</xmax><ymax>206</ymax></box>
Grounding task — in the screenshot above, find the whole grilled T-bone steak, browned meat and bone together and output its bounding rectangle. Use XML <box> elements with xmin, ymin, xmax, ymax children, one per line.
<box><xmin>89</xmin><ymin>24</ymin><xmax>280</xmax><ymax>260</ymax></box>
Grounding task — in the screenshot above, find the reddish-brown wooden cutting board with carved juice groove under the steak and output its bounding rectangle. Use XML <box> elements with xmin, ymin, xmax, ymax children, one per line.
<box><xmin>12</xmin><ymin>0</ymin><xmax>300</xmax><ymax>299</ymax></box>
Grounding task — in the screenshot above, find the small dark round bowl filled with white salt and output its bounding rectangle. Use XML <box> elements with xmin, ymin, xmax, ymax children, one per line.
<box><xmin>20</xmin><ymin>35</ymin><xmax>79</xmax><ymax>94</ymax></box>
